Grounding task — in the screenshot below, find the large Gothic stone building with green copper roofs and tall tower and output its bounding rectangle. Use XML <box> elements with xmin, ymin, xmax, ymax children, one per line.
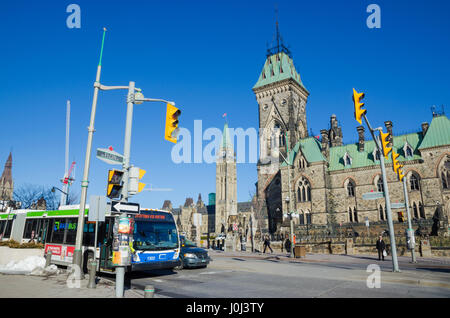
<box><xmin>253</xmin><ymin>29</ymin><xmax>450</xmax><ymax>235</ymax></box>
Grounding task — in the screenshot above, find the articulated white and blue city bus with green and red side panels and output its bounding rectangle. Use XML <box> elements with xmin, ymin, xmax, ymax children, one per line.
<box><xmin>0</xmin><ymin>206</ymin><xmax>180</xmax><ymax>272</ymax></box>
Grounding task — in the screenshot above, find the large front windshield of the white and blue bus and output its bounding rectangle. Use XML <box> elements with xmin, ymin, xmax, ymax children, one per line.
<box><xmin>133</xmin><ymin>221</ymin><xmax>178</xmax><ymax>251</ymax></box>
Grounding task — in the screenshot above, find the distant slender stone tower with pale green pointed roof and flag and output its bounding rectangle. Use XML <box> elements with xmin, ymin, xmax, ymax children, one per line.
<box><xmin>215</xmin><ymin>123</ymin><xmax>237</xmax><ymax>234</ymax></box>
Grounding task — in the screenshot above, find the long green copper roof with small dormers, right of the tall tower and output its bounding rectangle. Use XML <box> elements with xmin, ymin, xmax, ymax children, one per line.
<box><xmin>328</xmin><ymin>132</ymin><xmax>422</xmax><ymax>171</ymax></box>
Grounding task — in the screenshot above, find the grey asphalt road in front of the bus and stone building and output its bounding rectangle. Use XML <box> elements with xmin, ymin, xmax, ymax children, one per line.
<box><xmin>111</xmin><ymin>251</ymin><xmax>450</xmax><ymax>298</ymax></box>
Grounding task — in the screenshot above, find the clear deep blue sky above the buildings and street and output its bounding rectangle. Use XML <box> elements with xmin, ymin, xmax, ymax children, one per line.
<box><xmin>0</xmin><ymin>0</ymin><xmax>450</xmax><ymax>208</ymax></box>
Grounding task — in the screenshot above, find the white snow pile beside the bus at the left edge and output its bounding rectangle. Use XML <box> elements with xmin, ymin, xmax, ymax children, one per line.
<box><xmin>0</xmin><ymin>256</ymin><xmax>59</xmax><ymax>276</ymax></box>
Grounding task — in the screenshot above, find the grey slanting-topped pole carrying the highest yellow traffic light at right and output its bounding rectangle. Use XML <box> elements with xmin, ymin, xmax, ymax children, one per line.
<box><xmin>363</xmin><ymin>114</ymin><xmax>400</xmax><ymax>272</ymax></box>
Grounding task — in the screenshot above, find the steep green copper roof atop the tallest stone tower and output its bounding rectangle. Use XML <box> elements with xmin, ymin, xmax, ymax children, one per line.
<box><xmin>253</xmin><ymin>52</ymin><xmax>306</xmax><ymax>90</ymax></box>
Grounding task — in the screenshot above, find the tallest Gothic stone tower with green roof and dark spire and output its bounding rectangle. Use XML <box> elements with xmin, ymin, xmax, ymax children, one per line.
<box><xmin>253</xmin><ymin>30</ymin><xmax>309</xmax><ymax>233</ymax></box>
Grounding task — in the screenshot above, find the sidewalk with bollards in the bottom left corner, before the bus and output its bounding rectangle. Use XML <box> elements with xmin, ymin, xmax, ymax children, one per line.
<box><xmin>0</xmin><ymin>273</ymin><xmax>151</xmax><ymax>298</ymax></box>
